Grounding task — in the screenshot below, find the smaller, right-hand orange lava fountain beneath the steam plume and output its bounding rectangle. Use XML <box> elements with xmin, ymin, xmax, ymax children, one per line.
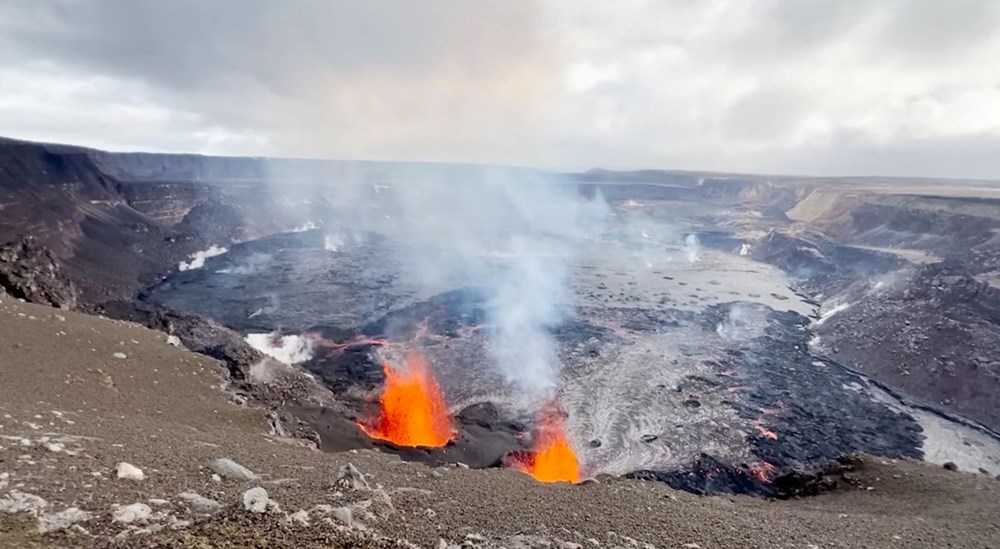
<box><xmin>514</xmin><ymin>403</ymin><xmax>580</xmax><ymax>482</ymax></box>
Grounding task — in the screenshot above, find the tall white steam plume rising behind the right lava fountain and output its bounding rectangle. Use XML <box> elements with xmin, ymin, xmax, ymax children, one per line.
<box><xmin>391</xmin><ymin>169</ymin><xmax>608</xmax><ymax>397</ymax></box>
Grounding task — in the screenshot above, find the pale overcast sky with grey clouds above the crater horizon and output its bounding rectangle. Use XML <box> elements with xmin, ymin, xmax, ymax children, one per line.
<box><xmin>0</xmin><ymin>0</ymin><xmax>1000</xmax><ymax>178</ymax></box>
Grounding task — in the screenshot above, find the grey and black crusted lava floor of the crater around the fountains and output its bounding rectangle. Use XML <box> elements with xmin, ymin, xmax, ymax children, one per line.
<box><xmin>142</xmin><ymin>209</ymin><xmax>1000</xmax><ymax>494</ymax></box>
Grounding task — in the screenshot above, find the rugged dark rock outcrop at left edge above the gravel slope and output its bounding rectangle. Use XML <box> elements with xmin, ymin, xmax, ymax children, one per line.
<box><xmin>0</xmin><ymin>236</ymin><xmax>78</xmax><ymax>309</ymax></box>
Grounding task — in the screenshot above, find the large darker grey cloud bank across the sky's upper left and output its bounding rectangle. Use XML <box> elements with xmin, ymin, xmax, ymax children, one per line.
<box><xmin>3</xmin><ymin>0</ymin><xmax>538</xmax><ymax>85</ymax></box>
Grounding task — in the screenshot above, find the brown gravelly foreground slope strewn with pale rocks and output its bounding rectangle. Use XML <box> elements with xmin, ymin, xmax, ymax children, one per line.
<box><xmin>0</xmin><ymin>295</ymin><xmax>1000</xmax><ymax>549</ymax></box>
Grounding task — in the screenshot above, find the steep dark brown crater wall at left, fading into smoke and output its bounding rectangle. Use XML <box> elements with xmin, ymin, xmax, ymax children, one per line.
<box><xmin>0</xmin><ymin>136</ymin><xmax>302</xmax><ymax>303</ymax></box>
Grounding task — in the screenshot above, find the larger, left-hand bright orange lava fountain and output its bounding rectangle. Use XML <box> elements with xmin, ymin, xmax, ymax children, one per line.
<box><xmin>360</xmin><ymin>352</ymin><xmax>455</xmax><ymax>448</ymax></box>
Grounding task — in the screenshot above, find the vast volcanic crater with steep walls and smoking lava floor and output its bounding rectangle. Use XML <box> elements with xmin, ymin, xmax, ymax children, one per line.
<box><xmin>0</xmin><ymin>141</ymin><xmax>1000</xmax><ymax>496</ymax></box>
